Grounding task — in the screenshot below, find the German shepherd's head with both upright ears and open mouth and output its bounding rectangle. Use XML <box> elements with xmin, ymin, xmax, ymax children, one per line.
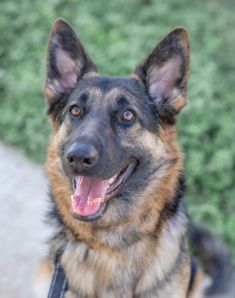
<box><xmin>45</xmin><ymin>20</ymin><xmax>189</xmax><ymax>227</ymax></box>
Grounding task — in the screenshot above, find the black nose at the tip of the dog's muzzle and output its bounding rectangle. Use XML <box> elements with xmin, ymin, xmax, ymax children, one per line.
<box><xmin>67</xmin><ymin>142</ymin><xmax>98</xmax><ymax>171</ymax></box>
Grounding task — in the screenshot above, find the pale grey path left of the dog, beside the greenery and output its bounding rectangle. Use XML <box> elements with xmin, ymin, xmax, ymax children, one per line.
<box><xmin>0</xmin><ymin>143</ymin><xmax>50</xmax><ymax>298</ymax></box>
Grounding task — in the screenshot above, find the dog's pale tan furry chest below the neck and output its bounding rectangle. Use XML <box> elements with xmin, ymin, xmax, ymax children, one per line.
<box><xmin>59</xmin><ymin>233</ymin><xmax>187</xmax><ymax>298</ymax></box>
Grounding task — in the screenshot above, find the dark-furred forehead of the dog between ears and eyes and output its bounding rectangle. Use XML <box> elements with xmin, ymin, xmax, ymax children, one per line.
<box><xmin>68</xmin><ymin>76</ymin><xmax>144</xmax><ymax>106</ymax></box>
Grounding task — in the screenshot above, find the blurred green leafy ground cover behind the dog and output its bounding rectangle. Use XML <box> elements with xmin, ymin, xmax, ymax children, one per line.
<box><xmin>0</xmin><ymin>0</ymin><xmax>235</xmax><ymax>298</ymax></box>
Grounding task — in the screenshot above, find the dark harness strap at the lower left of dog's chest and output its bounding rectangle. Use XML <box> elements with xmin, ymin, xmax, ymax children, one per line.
<box><xmin>48</xmin><ymin>258</ymin><xmax>68</xmax><ymax>298</ymax></box>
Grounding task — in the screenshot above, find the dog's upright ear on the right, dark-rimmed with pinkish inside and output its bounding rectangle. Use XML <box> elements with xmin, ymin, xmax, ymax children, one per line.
<box><xmin>135</xmin><ymin>28</ymin><xmax>189</xmax><ymax>114</ymax></box>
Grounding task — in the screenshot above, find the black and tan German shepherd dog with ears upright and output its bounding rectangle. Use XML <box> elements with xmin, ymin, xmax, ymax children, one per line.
<box><xmin>40</xmin><ymin>19</ymin><xmax>234</xmax><ymax>298</ymax></box>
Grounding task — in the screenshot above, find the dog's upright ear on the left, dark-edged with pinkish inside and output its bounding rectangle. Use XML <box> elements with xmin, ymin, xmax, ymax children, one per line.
<box><xmin>45</xmin><ymin>19</ymin><xmax>96</xmax><ymax>99</ymax></box>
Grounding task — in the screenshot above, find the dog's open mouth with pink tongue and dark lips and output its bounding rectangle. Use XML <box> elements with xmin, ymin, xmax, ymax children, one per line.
<box><xmin>71</xmin><ymin>160</ymin><xmax>137</xmax><ymax>220</ymax></box>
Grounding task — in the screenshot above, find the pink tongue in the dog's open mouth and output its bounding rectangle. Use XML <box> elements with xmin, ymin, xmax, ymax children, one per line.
<box><xmin>71</xmin><ymin>177</ymin><xmax>109</xmax><ymax>216</ymax></box>
